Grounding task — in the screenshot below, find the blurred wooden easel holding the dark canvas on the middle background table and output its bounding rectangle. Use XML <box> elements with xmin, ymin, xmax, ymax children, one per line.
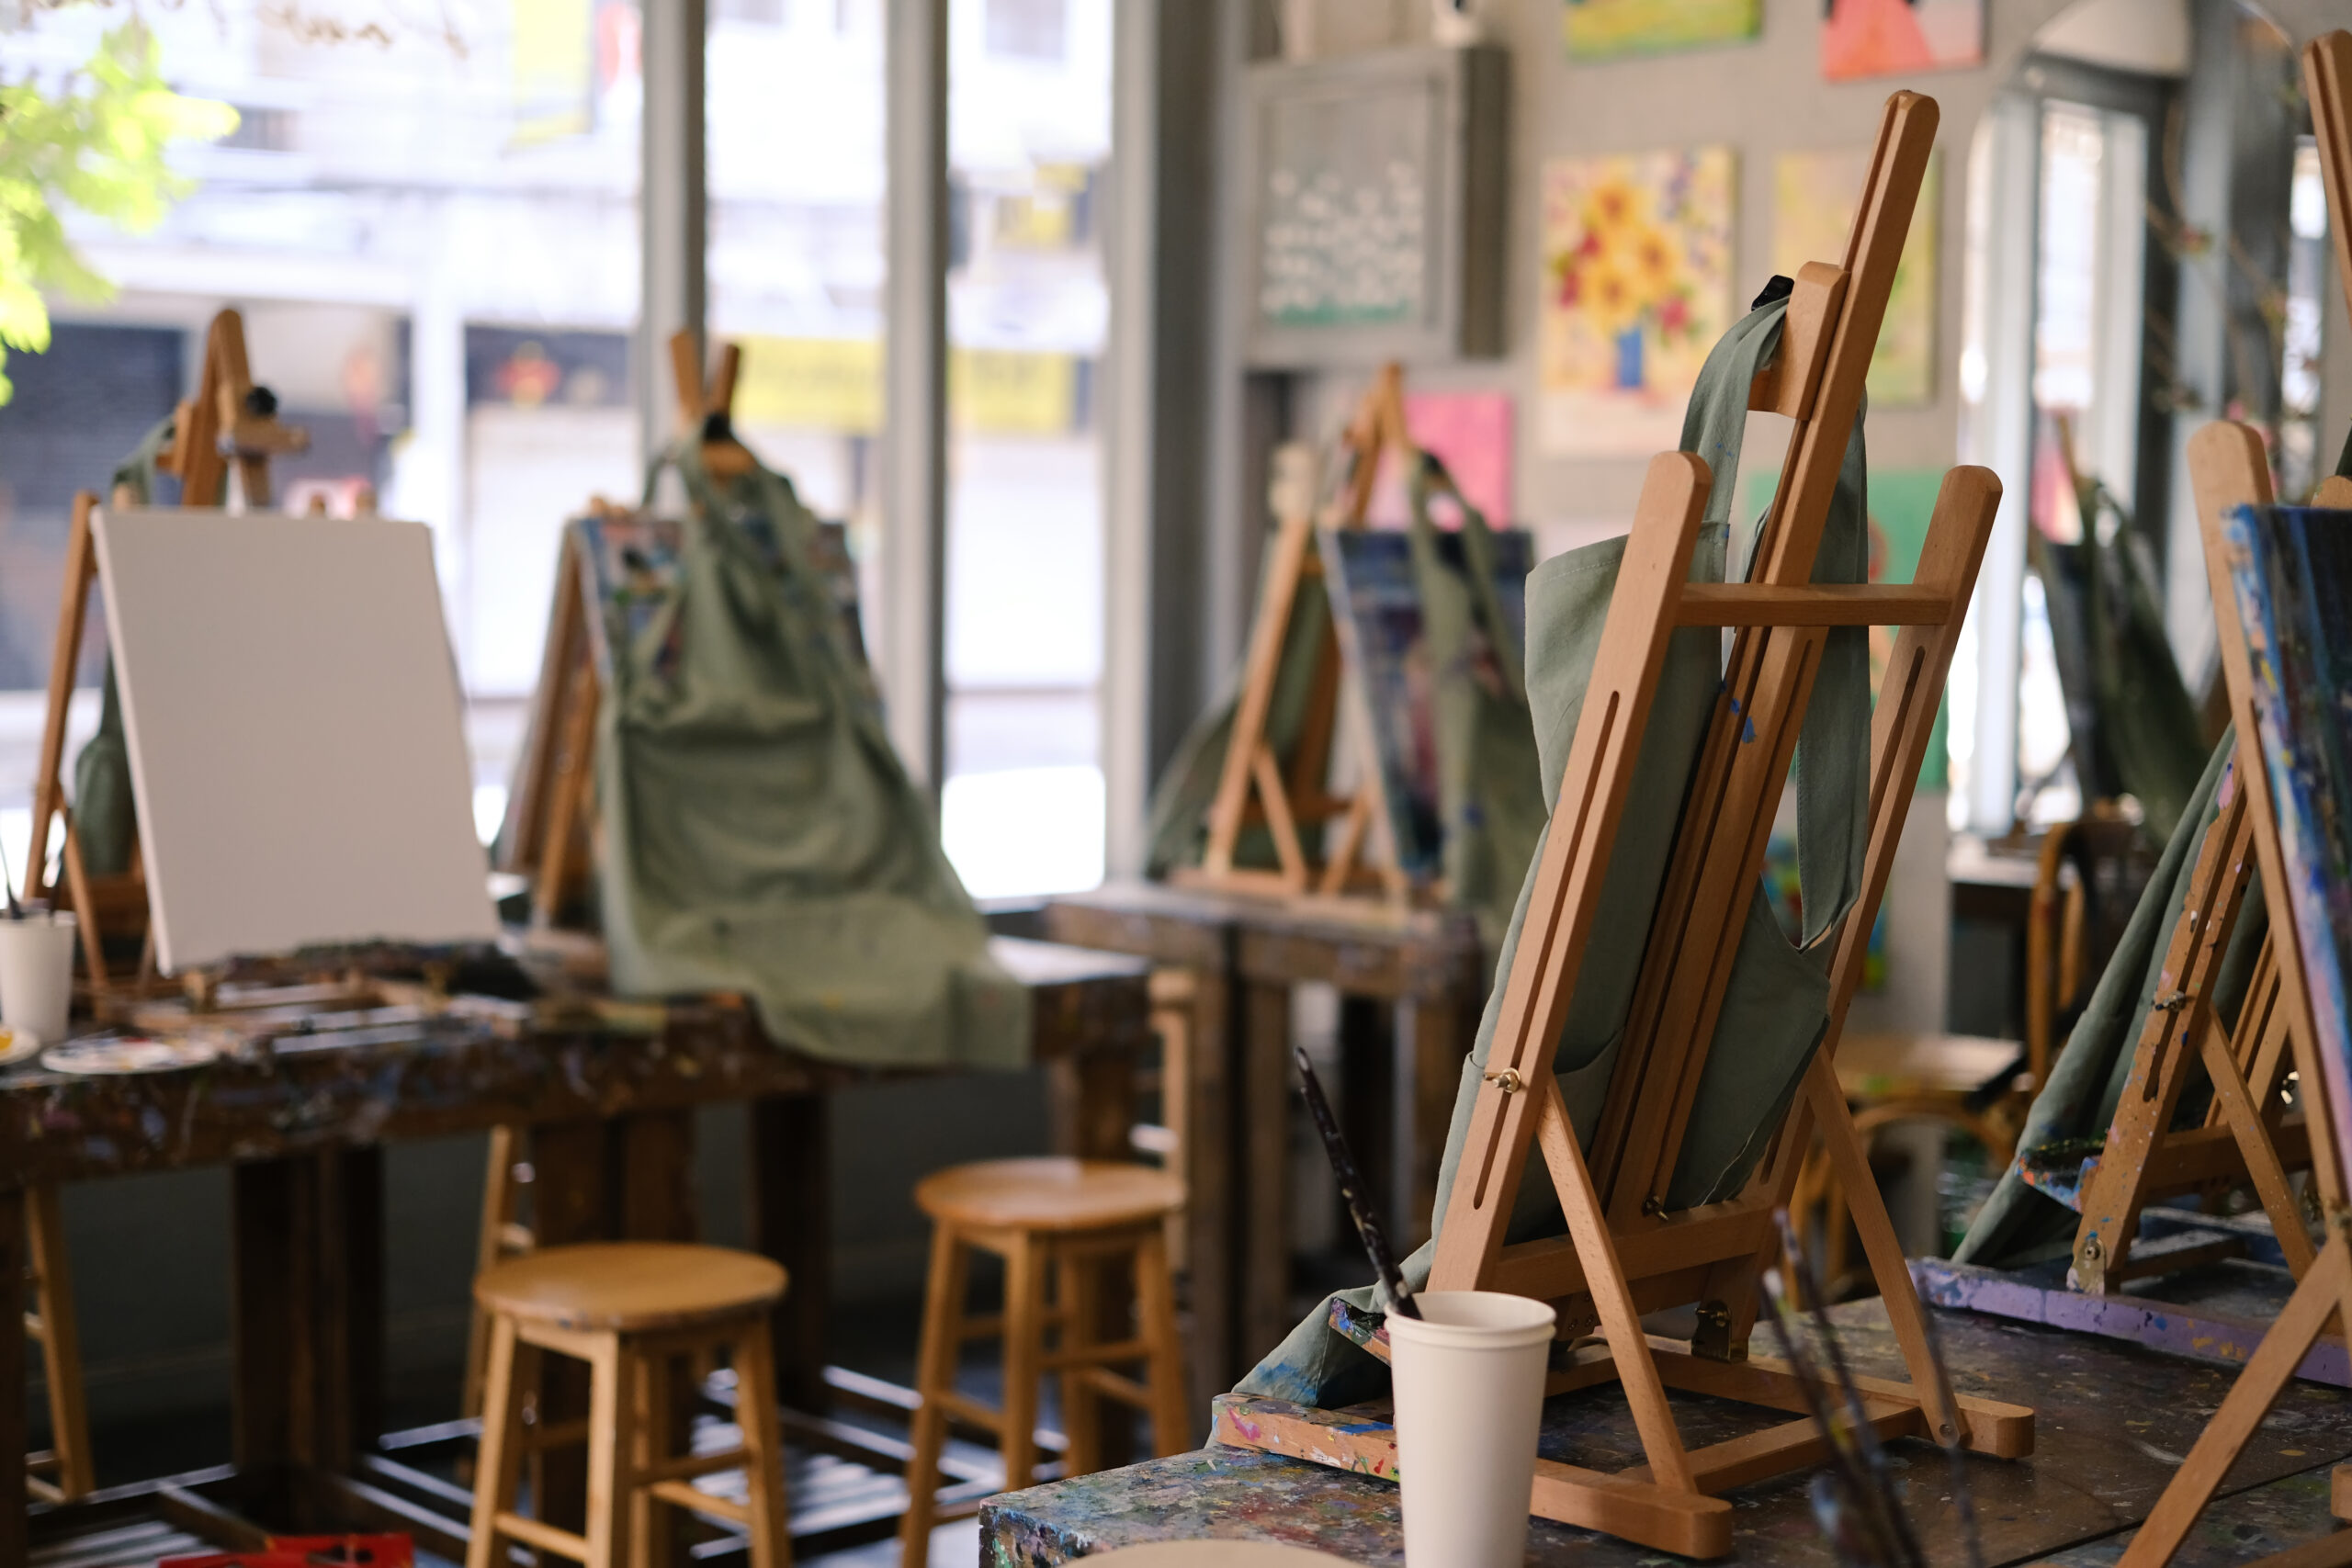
<box><xmin>1169</xmin><ymin>365</ymin><xmax>1419</xmax><ymax>900</ymax></box>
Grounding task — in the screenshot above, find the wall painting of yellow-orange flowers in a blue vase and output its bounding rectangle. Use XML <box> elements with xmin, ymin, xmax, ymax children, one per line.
<box><xmin>1538</xmin><ymin>148</ymin><xmax>1734</xmax><ymax>456</ymax></box>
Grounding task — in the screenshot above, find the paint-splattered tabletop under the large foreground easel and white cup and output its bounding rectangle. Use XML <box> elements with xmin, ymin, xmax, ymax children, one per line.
<box><xmin>981</xmin><ymin>1303</ymin><xmax>2352</xmax><ymax>1568</ymax></box>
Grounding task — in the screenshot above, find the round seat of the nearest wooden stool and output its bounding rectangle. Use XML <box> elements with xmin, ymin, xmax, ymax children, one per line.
<box><xmin>473</xmin><ymin>1241</ymin><xmax>786</xmax><ymax>1333</ymax></box>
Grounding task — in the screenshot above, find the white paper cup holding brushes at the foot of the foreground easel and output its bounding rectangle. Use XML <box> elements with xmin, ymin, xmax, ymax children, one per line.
<box><xmin>1387</xmin><ymin>1291</ymin><xmax>1553</xmax><ymax>1568</ymax></box>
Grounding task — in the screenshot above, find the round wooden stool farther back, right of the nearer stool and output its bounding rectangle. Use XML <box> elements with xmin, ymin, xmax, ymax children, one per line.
<box><xmin>899</xmin><ymin>1159</ymin><xmax>1190</xmax><ymax>1568</ymax></box>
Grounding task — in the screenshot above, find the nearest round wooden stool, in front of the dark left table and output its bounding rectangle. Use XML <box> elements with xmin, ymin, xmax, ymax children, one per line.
<box><xmin>466</xmin><ymin>1241</ymin><xmax>793</xmax><ymax>1568</ymax></box>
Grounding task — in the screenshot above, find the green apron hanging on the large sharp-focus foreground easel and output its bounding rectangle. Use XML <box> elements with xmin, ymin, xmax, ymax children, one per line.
<box><xmin>1242</xmin><ymin>296</ymin><xmax>1870</xmax><ymax>1405</ymax></box>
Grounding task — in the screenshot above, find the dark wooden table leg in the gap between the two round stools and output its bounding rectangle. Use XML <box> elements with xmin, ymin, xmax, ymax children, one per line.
<box><xmin>751</xmin><ymin>1093</ymin><xmax>832</xmax><ymax>1416</ymax></box>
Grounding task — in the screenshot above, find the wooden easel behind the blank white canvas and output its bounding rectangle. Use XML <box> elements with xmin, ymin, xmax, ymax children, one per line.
<box><xmin>24</xmin><ymin>310</ymin><xmax>311</xmax><ymax>1016</ymax></box>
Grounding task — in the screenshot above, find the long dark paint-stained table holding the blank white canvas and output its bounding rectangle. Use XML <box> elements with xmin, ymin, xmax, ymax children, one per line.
<box><xmin>0</xmin><ymin>938</ymin><xmax>1148</xmax><ymax>1563</ymax></box>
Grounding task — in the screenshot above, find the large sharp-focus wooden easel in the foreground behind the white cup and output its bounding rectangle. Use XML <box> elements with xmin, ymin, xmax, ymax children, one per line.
<box><xmin>1223</xmin><ymin>92</ymin><xmax>2032</xmax><ymax>1556</ymax></box>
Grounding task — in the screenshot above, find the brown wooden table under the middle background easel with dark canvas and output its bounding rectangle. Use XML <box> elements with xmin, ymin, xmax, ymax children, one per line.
<box><xmin>1045</xmin><ymin>882</ymin><xmax>1491</xmax><ymax>1405</ymax></box>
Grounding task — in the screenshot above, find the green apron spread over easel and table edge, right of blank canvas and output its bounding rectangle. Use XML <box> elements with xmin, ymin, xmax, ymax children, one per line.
<box><xmin>595</xmin><ymin>442</ymin><xmax>1030</xmax><ymax>1067</ymax></box>
